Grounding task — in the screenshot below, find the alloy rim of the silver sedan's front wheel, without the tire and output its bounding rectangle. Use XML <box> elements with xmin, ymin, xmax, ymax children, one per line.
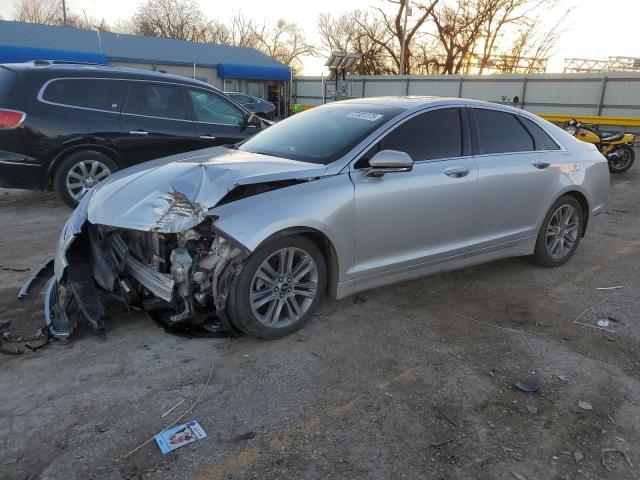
<box><xmin>249</xmin><ymin>247</ymin><xmax>318</xmax><ymax>328</ymax></box>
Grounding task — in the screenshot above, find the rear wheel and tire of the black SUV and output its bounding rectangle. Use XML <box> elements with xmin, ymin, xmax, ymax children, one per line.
<box><xmin>53</xmin><ymin>150</ymin><xmax>118</xmax><ymax>208</ymax></box>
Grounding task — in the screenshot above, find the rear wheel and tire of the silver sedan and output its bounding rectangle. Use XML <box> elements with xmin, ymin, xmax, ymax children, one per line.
<box><xmin>532</xmin><ymin>195</ymin><xmax>584</xmax><ymax>267</ymax></box>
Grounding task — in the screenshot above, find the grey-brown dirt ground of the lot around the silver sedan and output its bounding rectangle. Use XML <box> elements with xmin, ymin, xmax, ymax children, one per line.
<box><xmin>0</xmin><ymin>159</ymin><xmax>640</xmax><ymax>480</ymax></box>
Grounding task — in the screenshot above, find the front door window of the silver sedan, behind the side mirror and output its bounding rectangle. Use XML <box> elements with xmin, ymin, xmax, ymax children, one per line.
<box><xmin>378</xmin><ymin>108</ymin><xmax>462</xmax><ymax>162</ymax></box>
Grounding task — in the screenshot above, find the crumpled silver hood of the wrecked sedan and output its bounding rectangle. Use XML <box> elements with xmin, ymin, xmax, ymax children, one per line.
<box><xmin>88</xmin><ymin>147</ymin><xmax>326</xmax><ymax>233</ymax></box>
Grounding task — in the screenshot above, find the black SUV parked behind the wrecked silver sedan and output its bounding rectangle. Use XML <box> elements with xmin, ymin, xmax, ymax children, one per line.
<box><xmin>0</xmin><ymin>61</ymin><xmax>266</xmax><ymax>206</ymax></box>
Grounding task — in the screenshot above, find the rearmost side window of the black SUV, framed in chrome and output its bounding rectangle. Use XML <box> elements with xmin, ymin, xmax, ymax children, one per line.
<box><xmin>42</xmin><ymin>78</ymin><xmax>127</xmax><ymax>112</ymax></box>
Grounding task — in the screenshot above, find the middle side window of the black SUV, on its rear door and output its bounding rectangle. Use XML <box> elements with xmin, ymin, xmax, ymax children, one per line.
<box><xmin>137</xmin><ymin>82</ymin><xmax>190</xmax><ymax>120</ymax></box>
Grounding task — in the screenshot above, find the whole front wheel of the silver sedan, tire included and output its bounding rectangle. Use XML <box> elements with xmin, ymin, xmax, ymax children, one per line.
<box><xmin>227</xmin><ymin>235</ymin><xmax>327</xmax><ymax>340</ymax></box>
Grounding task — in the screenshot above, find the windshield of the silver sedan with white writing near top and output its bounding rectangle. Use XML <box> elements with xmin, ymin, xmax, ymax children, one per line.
<box><xmin>239</xmin><ymin>103</ymin><xmax>403</xmax><ymax>165</ymax></box>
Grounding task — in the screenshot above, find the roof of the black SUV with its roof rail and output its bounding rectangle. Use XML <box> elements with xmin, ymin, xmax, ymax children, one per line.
<box><xmin>2</xmin><ymin>60</ymin><xmax>218</xmax><ymax>90</ymax></box>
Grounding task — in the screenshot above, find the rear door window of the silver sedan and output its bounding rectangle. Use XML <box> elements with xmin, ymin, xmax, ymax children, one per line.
<box><xmin>473</xmin><ymin>108</ymin><xmax>535</xmax><ymax>154</ymax></box>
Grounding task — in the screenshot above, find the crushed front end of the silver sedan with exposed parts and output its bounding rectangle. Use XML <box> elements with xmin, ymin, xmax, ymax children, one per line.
<box><xmin>45</xmin><ymin>195</ymin><xmax>247</xmax><ymax>338</ymax></box>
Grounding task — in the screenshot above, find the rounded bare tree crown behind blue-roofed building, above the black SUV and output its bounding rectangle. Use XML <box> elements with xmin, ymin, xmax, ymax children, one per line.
<box><xmin>131</xmin><ymin>0</ymin><xmax>207</xmax><ymax>41</ymax></box>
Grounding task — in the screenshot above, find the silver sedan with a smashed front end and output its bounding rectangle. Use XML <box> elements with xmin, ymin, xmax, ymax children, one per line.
<box><xmin>46</xmin><ymin>97</ymin><xmax>609</xmax><ymax>339</ymax></box>
